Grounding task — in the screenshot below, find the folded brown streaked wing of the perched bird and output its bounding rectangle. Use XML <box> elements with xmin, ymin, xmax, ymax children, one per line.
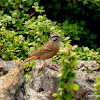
<box><xmin>29</xmin><ymin>42</ymin><xmax>54</xmax><ymax>58</ymax></box>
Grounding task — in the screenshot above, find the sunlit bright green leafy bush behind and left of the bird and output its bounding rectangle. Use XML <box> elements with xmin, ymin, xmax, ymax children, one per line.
<box><xmin>0</xmin><ymin>0</ymin><xmax>60</xmax><ymax>60</ymax></box>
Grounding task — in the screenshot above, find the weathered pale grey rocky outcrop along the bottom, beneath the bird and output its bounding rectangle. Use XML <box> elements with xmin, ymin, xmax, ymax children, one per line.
<box><xmin>0</xmin><ymin>60</ymin><xmax>100</xmax><ymax>100</ymax></box>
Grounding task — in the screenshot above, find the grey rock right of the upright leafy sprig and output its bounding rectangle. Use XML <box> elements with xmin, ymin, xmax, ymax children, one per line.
<box><xmin>75</xmin><ymin>61</ymin><xmax>100</xmax><ymax>100</ymax></box>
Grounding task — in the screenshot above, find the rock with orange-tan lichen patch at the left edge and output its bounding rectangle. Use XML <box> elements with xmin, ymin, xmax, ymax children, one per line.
<box><xmin>0</xmin><ymin>60</ymin><xmax>25</xmax><ymax>100</ymax></box>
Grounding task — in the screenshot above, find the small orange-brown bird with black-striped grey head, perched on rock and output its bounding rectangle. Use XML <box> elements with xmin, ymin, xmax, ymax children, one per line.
<box><xmin>22</xmin><ymin>33</ymin><xmax>61</xmax><ymax>65</ymax></box>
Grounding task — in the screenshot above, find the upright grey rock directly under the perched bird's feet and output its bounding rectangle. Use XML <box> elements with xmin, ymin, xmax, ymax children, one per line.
<box><xmin>30</xmin><ymin>60</ymin><xmax>60</xmax><ymax>100</ymax></box>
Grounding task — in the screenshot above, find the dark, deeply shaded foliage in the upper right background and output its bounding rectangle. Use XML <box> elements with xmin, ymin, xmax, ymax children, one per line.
<box><xmin>40</xmin><ymin>0</ymin><xmax>100</xmax><ymax>49</ymax></box>
